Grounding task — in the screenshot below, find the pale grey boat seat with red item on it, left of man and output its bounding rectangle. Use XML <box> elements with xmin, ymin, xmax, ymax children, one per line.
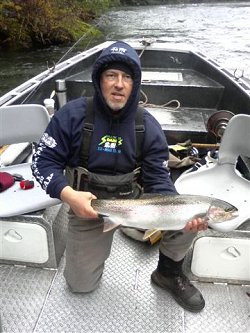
<box><xmin>0</xmin><ymin>104</ymin><xmax>60</xmax><ymax>217</ymax></box>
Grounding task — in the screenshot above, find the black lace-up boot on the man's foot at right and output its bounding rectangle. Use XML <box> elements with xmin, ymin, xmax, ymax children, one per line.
<box><xmin>151</xmin><ymin>252</ymin><xmax>205</xmax><ymax>312</ymax></box>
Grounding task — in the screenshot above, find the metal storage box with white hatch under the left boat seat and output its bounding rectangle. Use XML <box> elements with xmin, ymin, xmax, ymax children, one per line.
<box><xmin>0</xmin><ymin>204</ymin><xmax>68</xmax><ymax>268</ymax></box>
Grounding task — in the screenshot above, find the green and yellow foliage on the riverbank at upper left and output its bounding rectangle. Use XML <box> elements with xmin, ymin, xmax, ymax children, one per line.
<box><xmin>0</xmin><ymin>0</ymin><xmax>120</xmax><ymax>49</ymax></box>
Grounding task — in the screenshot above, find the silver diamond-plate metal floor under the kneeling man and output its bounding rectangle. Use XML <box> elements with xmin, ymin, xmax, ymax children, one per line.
<box><xmin>0</xmin><ymin>230</ymin><xmax>250</xmax><ymax>333</ymax></box>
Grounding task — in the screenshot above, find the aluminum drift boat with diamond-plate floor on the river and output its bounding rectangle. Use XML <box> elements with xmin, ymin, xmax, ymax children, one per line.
<box><xmin>0</xmin><ymin>40</ymin><xmax>250</xmax><ymax>333</ymax></box>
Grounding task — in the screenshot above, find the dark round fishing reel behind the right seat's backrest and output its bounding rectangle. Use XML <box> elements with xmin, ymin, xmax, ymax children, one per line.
<box><xmin>207</xmin><ymin>110</ymin><xmax>234</xmax><ymax>139</ymax></box>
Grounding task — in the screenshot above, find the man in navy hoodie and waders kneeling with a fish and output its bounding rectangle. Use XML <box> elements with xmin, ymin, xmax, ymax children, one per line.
<box><xmin>32</xmin><ymin>42</ymin><xmax>207</xmax><ymax>312</ymax></box>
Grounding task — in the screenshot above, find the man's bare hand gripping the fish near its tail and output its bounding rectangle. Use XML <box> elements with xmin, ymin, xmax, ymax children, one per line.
<box><xmin>60</xmin><ymin>186</ymin><xmax>98</xmax><ymax>218</ymax></box>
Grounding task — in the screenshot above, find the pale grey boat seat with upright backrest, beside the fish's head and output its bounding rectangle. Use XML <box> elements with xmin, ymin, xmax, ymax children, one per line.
<box><xmin>175</xmin><ymin>114</ymin><xmax>250</xmax><ymax>232</ymax></box>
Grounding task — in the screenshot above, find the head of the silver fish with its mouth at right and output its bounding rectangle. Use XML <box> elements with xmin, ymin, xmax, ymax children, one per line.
<box><xmin>206</xmin><ymin>199</ymin><xmax>239</xmax><ymax>223</ymax></box>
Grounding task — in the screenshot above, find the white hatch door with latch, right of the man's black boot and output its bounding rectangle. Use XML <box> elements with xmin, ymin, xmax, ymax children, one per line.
<box><xmin>191</xmin><ymin>237</ymin><xmax>250</xmax><ymax>282</ymax></box>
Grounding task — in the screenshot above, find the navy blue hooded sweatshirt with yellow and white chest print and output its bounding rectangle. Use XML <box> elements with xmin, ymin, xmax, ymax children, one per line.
<box><xmin>32</xmin><ymin>42</ymin><xmax>177</xmax><ymax>198</ymax></box>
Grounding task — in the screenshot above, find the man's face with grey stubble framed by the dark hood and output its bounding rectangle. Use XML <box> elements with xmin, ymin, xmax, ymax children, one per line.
<box><xmin>100</xmin><ymin>69</ymin><xmax>133</xmax><ymax>111</ymax></box>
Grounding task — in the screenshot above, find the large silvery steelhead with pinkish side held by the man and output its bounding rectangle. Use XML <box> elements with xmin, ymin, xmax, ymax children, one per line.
<box><xmin>91</xmin><ymin>194</ymin><xmax>238</xmax><ymax>231</ymax></box>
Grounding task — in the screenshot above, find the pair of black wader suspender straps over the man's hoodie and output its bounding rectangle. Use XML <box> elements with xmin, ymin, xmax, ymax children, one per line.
<box><xmin>79</xmin><ymin>97</ymin><xmax>145</xmax><ymax>169</ymax></box>
